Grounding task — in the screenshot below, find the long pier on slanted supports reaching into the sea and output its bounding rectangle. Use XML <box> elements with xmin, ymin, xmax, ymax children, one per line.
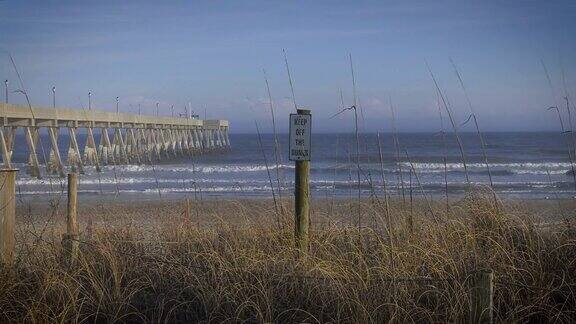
<box><xmin>0</xmin><ymin>103</ymin><xmax>230</xmax><ymax>177</ymax></box>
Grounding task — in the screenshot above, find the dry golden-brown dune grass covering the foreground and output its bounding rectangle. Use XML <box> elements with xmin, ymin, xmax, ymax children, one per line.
<box><xmin>0</xmin><ymin>194</ymin><xmax>576</xmax><ymax>323</ymax></box>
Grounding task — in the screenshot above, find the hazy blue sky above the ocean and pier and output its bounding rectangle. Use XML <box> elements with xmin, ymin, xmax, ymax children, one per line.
<box><xmin>0</xmin><ymin>0</ymin><xmax>576</xmax><ymax>132</ymax></box>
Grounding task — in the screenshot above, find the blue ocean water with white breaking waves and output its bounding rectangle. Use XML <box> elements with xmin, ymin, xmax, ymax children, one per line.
<box><xmin>5</xmin><ymin>132</ymin><xmax>575</xmax><ymax>199</ymax></box>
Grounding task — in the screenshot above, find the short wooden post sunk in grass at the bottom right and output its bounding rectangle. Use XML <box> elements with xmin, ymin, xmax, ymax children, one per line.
<box><xmin>470</xmin><ymin>270</ymin><xmax>494</xmax><ymax>324</ymax></box>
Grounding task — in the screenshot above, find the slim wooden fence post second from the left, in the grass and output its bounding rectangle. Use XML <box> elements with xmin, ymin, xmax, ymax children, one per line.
<box><xmin>62</xmin><ymin>173</ymin><xmax>80</xmax><ymax>264</ymax></box>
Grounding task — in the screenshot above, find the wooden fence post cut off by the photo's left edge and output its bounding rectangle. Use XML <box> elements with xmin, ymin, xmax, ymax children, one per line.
<box><xmin>0</xmin><ymin>169</ymin><xmax>18</xmax><ymax>265</ymax></box>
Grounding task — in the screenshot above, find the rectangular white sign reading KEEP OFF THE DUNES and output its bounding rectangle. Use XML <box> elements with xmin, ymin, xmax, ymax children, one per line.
<box><xmin>290</xmin><ymin>114</ymin><xmax>312</xmax><ymax>161</ymax></box>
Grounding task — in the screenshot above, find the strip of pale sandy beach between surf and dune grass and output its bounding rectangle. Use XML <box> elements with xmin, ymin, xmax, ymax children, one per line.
<box><xmin>17</xmin><ymin>195</ymin><xmax>576</xmax><ymax>227</ymax></box>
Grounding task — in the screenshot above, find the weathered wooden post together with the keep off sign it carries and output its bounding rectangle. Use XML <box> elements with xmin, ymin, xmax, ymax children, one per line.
<box><xmin>289</xmin><ymin>109</ymin><xmax>312</xmax><ymax>255</ymax></box>
